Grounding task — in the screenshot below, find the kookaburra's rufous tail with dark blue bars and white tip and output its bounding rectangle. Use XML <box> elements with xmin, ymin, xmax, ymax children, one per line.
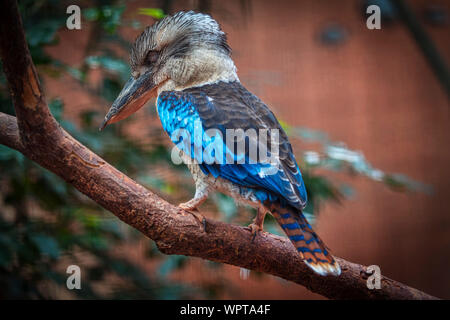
<box><xmin>270</xmin><ymin>204</ymin><xmax>341</xmax><ymax>276</ymax></box>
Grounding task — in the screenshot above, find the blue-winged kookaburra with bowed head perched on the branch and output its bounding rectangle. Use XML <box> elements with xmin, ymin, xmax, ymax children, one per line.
<box><xmin>101</xmin><ymin>11</ymin><xmax>341</xmax><ymax>275</ymax></box>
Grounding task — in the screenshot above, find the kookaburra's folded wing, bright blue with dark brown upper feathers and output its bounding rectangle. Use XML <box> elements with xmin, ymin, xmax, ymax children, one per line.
<box><xmin>157</xmin><ymin>82</ymin><xmax>307</xmax><ymax>209</ymax></box>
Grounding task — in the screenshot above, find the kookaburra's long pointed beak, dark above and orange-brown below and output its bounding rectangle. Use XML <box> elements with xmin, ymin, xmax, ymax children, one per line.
<box><xmin>99</xmin><ymin>71</ymin><xmax>156</xmax><ymax>131</ymax></box>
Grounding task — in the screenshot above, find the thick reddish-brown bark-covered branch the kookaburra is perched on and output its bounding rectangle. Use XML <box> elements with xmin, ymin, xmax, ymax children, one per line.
<box><xmin>0</xmin><ymin>0</ymin><xmax>436</xmax><ymax>299</ymax></box>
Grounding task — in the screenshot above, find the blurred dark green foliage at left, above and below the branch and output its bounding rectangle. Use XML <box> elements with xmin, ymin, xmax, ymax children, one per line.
<box><xmin>0</xmin><ymin>1</ymin><xmax>198</xmax><ymax>299</ymax></box>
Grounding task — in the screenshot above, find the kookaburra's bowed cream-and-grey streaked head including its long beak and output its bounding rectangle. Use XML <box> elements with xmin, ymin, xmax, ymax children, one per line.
<box><xmin>100</xmin><ymin>11</ymin><xmax>238</xmax><ymax>129</ymax></box>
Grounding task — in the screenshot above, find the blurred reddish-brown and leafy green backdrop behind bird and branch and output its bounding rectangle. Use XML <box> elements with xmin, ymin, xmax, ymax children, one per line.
<box><xmin>0</xmin><ymin>0</ymin><xmax>450</xmax><ymax>299</ymax></box>
